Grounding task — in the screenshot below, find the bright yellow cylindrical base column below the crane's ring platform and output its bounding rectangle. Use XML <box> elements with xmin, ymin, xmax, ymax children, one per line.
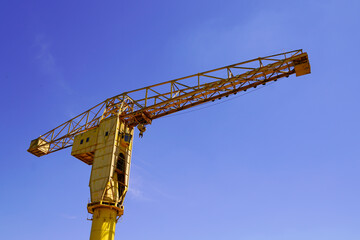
<box><xmin>90</xmin><ymin>207</ymin><xmax>117</xmax><ymax>240</ymax></box>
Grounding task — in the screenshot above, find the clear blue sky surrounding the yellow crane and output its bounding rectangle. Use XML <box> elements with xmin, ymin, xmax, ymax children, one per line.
<box><xmin>0</xmin><ymin>0</ymin><xmax>360</xmax><ymax>240</ymax></box>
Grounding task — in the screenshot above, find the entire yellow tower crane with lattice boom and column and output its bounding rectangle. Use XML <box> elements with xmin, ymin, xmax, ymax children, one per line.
<box><xmin>28</xmin><ymin>49</ymin><xmax>310</xmax><ymax>240</ymax></box>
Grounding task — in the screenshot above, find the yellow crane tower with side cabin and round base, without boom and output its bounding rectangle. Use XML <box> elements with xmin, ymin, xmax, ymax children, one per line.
<box><xmin>71</xmin><ymin>116</ymin><xmax>134</xmax><ymax>240</ymax></box>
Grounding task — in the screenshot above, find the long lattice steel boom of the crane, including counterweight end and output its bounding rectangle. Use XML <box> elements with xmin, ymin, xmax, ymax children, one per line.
<box><xmin>28</xmin><ymin>49</ymin><xmax>310</xmax><ymax>157</ymax></box>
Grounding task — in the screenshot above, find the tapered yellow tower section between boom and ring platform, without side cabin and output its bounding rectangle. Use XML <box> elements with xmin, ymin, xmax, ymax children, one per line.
<box><xmin>87</xmin><ymin>117</ymin><xmax>133</xmax><ymax>205</ymax></box>
